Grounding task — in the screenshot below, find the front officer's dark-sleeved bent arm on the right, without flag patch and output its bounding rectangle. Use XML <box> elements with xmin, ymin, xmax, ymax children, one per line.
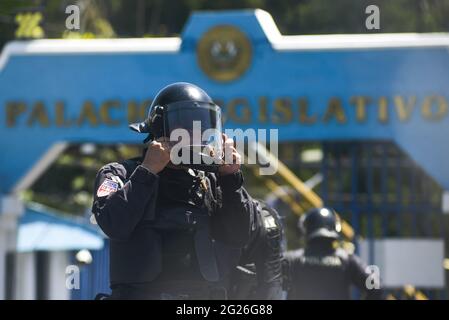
<box><xmin>212</xmin><ymin>171</ymin><xmax>256</xmax><ymax>247</ymax></box>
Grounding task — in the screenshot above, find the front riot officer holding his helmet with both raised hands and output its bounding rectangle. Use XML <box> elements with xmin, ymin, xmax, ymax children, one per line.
<box><xmin>92</xmin><ymin>83</ymin><xmax>255</xmax><ymax>299</ymax></box>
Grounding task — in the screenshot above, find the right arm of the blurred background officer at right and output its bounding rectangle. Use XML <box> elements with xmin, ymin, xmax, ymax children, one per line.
<box><xmin>348</xmin><ymin>255</ymin><xmax>384</xmax><ymax>300</ymax></box>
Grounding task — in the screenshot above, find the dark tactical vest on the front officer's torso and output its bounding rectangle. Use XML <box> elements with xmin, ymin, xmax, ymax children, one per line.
<box><xmin>110</xmin><ymin>160</ymin><xmax>240</xmax><ymax>287</ymax></box>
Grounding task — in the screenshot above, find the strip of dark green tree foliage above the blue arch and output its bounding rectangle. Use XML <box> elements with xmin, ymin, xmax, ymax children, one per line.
<box><xmin>0</xmin><ymin>0</ymin><xmax>449</xmax><ymax>45</ymax></box>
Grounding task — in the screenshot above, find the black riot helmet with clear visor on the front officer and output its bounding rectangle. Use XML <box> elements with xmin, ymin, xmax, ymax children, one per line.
<box><xmin>130</xmin><ymin>82</ymin><xmax>222</xmax><ymax>171</ymax></box>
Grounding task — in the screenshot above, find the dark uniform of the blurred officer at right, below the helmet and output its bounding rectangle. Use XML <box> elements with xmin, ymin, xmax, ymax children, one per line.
<box><xmin>285</xmin><ymin>239</ymin><xmax>382</xmax><ymax>300</ymax></box>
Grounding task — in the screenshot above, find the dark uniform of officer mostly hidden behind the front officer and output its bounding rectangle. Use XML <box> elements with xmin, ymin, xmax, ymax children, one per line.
<box><xmin>230</xmin><ymin>201</ymin><xmax>283</xmax><ymax>300</ymax></box>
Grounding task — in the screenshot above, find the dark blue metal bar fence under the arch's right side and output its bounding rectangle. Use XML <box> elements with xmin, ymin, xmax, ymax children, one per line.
<box><xmin>279</xmin><ymin>141</ymin><xmax>449</xmax><ymax>299</ymax></box>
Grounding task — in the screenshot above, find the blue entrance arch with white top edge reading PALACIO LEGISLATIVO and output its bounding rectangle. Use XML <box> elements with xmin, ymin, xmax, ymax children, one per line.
<box><xmin>0</xmin><ymin>10</ymin><xmax>449</xmax><ymax>193</ymax></box>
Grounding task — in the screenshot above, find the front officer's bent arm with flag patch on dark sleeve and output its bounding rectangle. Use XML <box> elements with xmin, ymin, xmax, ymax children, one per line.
<box><xmin>92</xmin><ymin>163</ymin><xmax>158</xmax><ymax>240</ymax></box>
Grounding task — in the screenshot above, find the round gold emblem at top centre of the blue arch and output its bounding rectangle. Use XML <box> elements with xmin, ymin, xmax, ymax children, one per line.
<box><xmin>197</xmin><ymin>25</ymin><xmax>252</xmax><ymax>82</ymax></box>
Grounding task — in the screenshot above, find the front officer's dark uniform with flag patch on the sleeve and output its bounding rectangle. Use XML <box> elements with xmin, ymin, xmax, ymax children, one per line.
<box><xmin>92</xmin><ymin>158</ymin><xmax>257</xmax><ymax>299</ymax></box>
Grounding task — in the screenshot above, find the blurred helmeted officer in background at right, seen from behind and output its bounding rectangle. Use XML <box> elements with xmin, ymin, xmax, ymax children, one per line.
<box><xmin>285</xmin><ymin>208</ymin><xmax>383</xmax><ymax>300</ymax></box>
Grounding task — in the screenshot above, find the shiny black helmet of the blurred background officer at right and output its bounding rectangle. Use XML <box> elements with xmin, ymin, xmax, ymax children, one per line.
<box><xmin>298</xmin><ymin>207</ymin><xmax>341</xmax><ymax>241</ymax></box>
